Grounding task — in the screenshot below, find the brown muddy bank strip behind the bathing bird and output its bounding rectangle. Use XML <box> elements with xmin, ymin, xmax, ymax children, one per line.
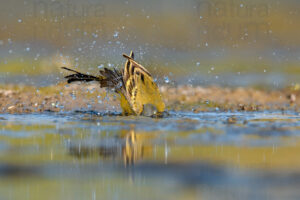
<box><xmin>0</xmin><ymin>83</ymin><xmax>300</xmax><ymax>113</ymax></box>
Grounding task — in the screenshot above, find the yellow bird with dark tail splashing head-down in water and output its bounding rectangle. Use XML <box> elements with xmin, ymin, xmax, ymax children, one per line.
<box><xmin>62</xmin><ymin>51</ymin><xmax>165</xmax><ymax>116</ymax></box>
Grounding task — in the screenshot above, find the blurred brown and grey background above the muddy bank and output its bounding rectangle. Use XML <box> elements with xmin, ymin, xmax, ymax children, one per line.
<box><xmin>0</xmin><ymin>0</ymin><xmax>300</xmax><ymax>88</ymax></box>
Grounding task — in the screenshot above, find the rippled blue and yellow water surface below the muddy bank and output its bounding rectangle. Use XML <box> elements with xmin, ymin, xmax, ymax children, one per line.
<box><xmin>0</xmin><ymin>112</ymin><xmax>300</xmax><ymax>200</ymax></box>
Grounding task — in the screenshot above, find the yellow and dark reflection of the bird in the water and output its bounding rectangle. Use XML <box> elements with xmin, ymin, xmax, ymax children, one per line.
<box><xmin>69</xmin><ymin>130</ymin><xmax>150</xmax><ymax>166</ymax></box>
